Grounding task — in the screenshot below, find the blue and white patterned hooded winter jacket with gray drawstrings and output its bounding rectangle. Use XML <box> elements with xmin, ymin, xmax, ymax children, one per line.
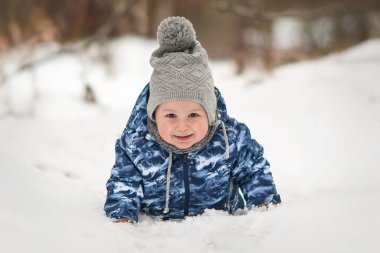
<box><xmin>104</xmin><ymin>85</ymin><xmax>281</xmax><ymax>222</ymax></box>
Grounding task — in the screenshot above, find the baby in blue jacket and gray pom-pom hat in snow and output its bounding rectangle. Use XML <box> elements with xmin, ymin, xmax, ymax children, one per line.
<box><xmin>104</xmin><ymin>17</ymin><xmax>281</xmax><ymax>222</ymax></box>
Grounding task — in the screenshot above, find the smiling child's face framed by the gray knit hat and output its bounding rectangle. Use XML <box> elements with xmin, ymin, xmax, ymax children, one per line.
<box><xmin>155</xmin><ymin>100</ymin><xmax>208</xmax><ymax>149</ymax></box>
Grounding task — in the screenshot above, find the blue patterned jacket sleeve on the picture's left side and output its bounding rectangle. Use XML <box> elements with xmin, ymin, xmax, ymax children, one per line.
<box><xmin>104</xmin><ymin>139</ymin><xmax>143</xmax><ymax>222</ymax></box>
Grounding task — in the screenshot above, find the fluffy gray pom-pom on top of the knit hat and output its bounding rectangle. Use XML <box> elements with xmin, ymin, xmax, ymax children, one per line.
<box><xmin>157</xmin><ymin>17</ymin><xmax>196</xmax><ymax>53</ymax></box>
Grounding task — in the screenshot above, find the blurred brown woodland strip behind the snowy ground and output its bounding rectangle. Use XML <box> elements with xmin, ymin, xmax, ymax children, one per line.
<box><xmin>0</xmin><ymin>0</ymin><xmax>380</xmax><ymax>73</ymax></box>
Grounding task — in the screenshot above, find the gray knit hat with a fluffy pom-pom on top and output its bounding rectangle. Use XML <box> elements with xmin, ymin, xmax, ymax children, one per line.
<box><xmin>147</xmin><ymin>17</ymin><xmax>216</xmax><ymax>125</ymax></box>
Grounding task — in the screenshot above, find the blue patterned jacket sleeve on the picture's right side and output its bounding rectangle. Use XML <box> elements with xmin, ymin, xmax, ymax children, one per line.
<box><xmin>233</xmin><ymin>123</ymin><xmax>281</xmax><ymax>209</ymax></box>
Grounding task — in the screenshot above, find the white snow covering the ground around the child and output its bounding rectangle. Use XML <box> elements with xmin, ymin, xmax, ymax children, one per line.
<box><xmin>0</xmin><ymin>37</ymin><xmax>380</xmax><ymax>253</ymax></box>
